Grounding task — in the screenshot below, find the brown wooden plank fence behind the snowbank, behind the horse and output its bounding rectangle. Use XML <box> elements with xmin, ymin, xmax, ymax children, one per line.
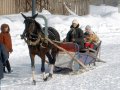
<box><xmin>0</xmin><ymin>0</ymin><xmax>89</xmax><ymax>15</ymax></box>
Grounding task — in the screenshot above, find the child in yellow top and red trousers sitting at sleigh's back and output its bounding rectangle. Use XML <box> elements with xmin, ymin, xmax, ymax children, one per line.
<box><xmin>84</xmin><ymin>25</ymin><xmax>100</xmax><ymax>49</ymax></box>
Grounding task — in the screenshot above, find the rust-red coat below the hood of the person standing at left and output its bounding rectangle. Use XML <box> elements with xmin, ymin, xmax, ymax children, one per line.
<box><xmin>0</xmin><ymin>31</ymin><xmax>12</xmax><ymax>52</ymax></box>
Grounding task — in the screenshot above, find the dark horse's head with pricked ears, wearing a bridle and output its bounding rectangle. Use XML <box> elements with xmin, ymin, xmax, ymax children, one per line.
<box><xmin>21</xmin><ymin>13</ymin><xmax>42</xmax><ymax>43</ymax></box>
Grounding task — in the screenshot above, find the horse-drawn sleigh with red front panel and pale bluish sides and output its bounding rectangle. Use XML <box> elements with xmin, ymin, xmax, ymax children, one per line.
<box><xmin>54</xmin><ymin>41</ymin><xmax>104</xmax><ymax>72</ymax></box>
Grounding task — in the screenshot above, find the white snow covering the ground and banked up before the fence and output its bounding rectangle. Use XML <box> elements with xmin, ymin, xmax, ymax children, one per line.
<box><xmin>0</xmin><ymin>5</ymin><xmax>120</xmax><ymax>90</ymax></box>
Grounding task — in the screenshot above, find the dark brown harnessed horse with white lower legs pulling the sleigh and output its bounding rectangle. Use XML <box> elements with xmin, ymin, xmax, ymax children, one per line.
<box><xmin>21</xmin><ymin>14</ymin><xmax>60</xmax><ymax>84</ymax></box>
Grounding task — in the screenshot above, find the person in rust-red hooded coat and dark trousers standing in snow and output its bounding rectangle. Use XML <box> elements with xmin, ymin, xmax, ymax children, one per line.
<box><xmin>0</xmin><ymin>24</ymin><xmax>13</xmax><ymax>73</ymax></box>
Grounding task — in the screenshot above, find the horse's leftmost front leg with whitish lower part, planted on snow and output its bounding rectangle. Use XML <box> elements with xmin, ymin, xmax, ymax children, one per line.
<box><xmin>30</xmin><ymin>54</ymin><xmax>36</xmax><ymax>85</ymax></box>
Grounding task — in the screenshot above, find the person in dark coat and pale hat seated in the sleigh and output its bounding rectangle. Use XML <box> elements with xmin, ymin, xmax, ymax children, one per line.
<box><xmin>66</xmin><ymin>19</ymin><xmax>84</xmax><ymax>50</ymax></box>
